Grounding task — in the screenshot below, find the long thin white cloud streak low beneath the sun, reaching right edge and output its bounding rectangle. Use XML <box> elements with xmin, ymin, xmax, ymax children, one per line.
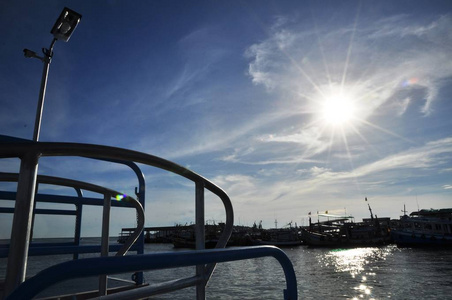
<box><xmin>222</xmin><ymin>138</ymin><xmax>452</xmax><ymax>204</ymax></box>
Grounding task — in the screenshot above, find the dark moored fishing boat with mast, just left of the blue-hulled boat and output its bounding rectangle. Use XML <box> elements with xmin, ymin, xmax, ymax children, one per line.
<box><xmin>301</xmin><ymin>204</ymin><xmax>392</xmax><ymax>247</ymax></box>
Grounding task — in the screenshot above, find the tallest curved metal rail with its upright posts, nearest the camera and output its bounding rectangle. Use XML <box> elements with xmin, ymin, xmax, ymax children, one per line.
<box><xmin>0</xmin><ymin>140</ymin><xmax>234</xmax><ymax>298</ymax></box>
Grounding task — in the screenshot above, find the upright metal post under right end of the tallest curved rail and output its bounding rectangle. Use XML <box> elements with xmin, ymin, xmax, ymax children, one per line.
<box><xmin>195</xmin><ymin>181</ymin><xmax>206</xmax><ymax>300</ymax></box>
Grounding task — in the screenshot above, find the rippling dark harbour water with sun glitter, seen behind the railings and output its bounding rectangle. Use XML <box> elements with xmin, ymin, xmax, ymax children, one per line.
<box><xmin>0</xmin><ymin>239</ymin><xmax>452</xmax><ymax>300</ymax></box>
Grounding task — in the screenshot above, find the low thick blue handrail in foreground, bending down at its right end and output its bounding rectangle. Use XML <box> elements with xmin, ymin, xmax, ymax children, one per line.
<box><xmin>6</xmin><ymin>246</ymin><xmax>298</xmax><ymax>300</ymax></box>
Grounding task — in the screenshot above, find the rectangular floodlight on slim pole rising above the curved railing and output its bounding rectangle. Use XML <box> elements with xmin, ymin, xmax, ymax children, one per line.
<box><xmin>24</xmin><ymin>7</ymin><xmax>82</xmax><ymax>142</ymax></box>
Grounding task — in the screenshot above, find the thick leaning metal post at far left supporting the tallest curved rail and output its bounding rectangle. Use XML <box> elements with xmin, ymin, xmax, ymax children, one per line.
<box><xmin>4</xmin><ymin>152</ymin><xmax>39</xmax><ymax>296</ymax></box>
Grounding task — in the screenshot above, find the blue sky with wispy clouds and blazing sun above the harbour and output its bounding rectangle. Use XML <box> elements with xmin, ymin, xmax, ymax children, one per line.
<box><xmin>0</xmin><ymin>0</ymin><xmax>452</xmax><ymax>238</ymax></box>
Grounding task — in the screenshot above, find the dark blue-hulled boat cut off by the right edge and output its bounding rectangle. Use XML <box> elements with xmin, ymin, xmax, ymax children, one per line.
<box><xmin>391</xmin><ymin>208</ymin><xmax>452</xmax><ymax>247</ymax></box>
